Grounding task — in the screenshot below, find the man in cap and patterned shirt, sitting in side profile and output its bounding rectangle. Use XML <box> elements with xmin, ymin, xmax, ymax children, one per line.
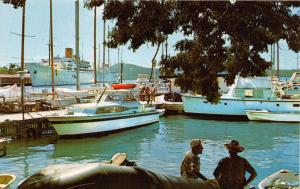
<box><xmin>180</xmin><ymin>139</ymin><xmax>207</xmax><ymax>180</ymax></box>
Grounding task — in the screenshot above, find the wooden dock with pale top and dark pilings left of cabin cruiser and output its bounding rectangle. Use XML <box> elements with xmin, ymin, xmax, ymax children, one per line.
<box><xmin>0</xmin><ymin>110</ymin><xmax>62</xmax><ymax>138</ymax></box>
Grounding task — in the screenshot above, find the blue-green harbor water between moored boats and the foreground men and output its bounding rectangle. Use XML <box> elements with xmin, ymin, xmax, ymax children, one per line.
<box><xmin>0</xmin><ymin>115</ymin><xmax>300</xmax><ymax>188</ymax></box>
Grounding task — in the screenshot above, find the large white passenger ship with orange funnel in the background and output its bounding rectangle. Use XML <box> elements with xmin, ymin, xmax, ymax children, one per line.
<box><xmin>25</xmin><ymin>48</ymin><xmax>117</xmax><ymax>86</ymax></box>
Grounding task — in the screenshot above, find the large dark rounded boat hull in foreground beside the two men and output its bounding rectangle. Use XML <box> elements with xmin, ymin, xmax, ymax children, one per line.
<box><xmin>18</xmin><ymin>163</ymin><xmax>218</xmax><ymax>189</ymax></box>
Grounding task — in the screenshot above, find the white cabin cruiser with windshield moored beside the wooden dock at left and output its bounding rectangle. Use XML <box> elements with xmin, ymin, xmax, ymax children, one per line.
<box><xmin>48</xmin><ymin>89</ymin><xmax>159</xmax><ymax>136</ymax></box>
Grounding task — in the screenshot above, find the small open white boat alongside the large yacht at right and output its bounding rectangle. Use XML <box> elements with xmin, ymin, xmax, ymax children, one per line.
<box><xmin>246</xmin><ymin>110</ymin><xmax>300</xmax><ymax>122</ymax></box>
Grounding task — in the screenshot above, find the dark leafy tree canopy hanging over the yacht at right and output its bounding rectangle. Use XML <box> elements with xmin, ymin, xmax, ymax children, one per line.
<box><xmin>59</xmin><ymin>0</ymin><xmax>300</xmax><ymax>102</ymax></box>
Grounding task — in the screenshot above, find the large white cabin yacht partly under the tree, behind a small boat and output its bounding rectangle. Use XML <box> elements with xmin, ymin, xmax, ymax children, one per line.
<box><xmin>182</xmin><ymin>76</ymin><xmax>300</xmax><ymax>119</ymax></box>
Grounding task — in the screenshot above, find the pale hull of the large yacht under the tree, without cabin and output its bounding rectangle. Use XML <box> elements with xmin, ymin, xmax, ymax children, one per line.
<box><xmin>182</xmin><ymin>94</ymin><xmax>300</xmax><ymax>118</ymax></box>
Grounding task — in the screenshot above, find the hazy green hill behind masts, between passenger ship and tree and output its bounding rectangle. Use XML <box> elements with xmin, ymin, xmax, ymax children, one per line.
<box><xmin>111</xmin><ymin>63</ymin><xmax>159</xmax><ymax>80</ymax></box>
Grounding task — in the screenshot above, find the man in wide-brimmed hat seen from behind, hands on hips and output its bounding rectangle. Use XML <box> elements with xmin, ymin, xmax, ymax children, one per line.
<box><xmin>213</xmin><ymin>140</ymin><xmax>257</xmax><ymax>189</ymax></box>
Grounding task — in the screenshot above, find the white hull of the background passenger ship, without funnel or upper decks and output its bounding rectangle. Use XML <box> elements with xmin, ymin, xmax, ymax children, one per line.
<box><xmin>26</xmin><ymin>63</ymin><xmax>116</xmax><ymax>86</ymax></box>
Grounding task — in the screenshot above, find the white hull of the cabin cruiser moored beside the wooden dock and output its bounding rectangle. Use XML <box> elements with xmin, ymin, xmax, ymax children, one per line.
<box><xmin>48</xmin><ymin>112</ymin><xmax>159</xmax><ymax>137</ymax></box>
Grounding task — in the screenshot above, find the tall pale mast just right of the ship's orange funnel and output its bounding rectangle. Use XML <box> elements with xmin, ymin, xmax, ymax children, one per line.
<box><xmin>75</xmin><ymin>0</ymin><xmax>80</xmax><ymax>90</ymax></box>
